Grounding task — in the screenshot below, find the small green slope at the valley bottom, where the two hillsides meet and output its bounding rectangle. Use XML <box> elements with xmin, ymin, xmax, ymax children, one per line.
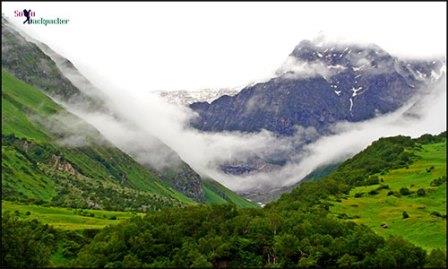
<box><xmin>203</xmin><ymin>180</ymin><xmax>258</xmax><ymax>208</ymax></box>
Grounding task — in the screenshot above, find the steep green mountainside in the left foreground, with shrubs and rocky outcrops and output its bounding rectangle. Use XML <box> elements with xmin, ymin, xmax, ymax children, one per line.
<box><xmin>2</xmin><ymin>71</ymin><xmax>193</xmax><ymax>210</ymax></box>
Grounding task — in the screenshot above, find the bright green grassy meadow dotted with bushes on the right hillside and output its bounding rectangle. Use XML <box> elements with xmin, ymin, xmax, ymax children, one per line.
<box><xmin>331</xmin><ymin>141</ymin><xmax>446</xmax><ymax>250</ymax></box>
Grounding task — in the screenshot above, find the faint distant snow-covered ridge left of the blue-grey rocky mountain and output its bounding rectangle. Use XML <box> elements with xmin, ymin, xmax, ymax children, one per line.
<box><xmin>159</xmin><ymin>88</ymin><xmax>239</xmax><ymax>105</ymax></box>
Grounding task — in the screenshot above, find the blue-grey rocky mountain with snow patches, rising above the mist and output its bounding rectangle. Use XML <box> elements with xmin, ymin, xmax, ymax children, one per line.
<box><xmin>190</xmin><ymin>41</ymin><xmax>445</xmax><ymax>136</ymax></box>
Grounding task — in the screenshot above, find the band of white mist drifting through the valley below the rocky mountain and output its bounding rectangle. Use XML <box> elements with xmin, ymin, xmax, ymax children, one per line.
<box><xmin>58</xmin><ymin>68</ymin><xmax>446</xmax><ymax>194</ymax></box>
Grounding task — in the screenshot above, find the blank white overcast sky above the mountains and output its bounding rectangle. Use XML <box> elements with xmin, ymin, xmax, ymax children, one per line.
<box><xmin>2</xmin><ymin>2</ymin><xmax>446</xmax><ymax>91</ymax></box>
